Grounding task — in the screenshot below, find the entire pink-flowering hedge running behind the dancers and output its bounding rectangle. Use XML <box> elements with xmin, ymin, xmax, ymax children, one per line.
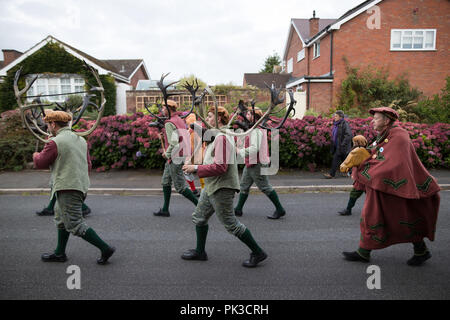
<box><xmin>74</xmin><ymin>113</ymin><xmax>450</xmax><ymax>171</ymax></box>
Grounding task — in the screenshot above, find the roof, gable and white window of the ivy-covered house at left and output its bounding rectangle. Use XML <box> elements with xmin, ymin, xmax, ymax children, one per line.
<box><xmin>0</xmin><ymin>35</ymin><xmax>150</xmax><ymax>114</ymax></box>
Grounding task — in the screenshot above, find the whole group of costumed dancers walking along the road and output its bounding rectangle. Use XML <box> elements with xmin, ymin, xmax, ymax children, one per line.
<box><xmin>33</xmin><ymin>100</ymin><xmax>440</xmax><ymax>268</ymax></box>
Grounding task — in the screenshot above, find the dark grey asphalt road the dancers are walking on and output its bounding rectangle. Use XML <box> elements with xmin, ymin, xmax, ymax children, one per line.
<box><xmin>0</xmin><ymin>191</ymin><xmax>450</xmax><ymax>300</ymax></box>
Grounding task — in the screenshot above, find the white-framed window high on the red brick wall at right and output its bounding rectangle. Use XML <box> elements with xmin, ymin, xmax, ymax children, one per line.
<box><xmin>391</xmin><ymin>29</ymin><xmax>436</xmax><ymax>51</ymax></box>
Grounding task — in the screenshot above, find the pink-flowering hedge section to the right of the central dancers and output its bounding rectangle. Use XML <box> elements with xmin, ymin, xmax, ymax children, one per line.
<box><xmin>280</xmin><ymin>116</ymin><xmax>450</xmax><ymax>171</ymax></box>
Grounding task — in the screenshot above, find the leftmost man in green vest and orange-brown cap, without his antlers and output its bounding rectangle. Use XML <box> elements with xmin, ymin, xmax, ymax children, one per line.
<box><xmin>33</xmin><ymin>111</ymin><xmax>115</xmax><ymax>264</ymax></box>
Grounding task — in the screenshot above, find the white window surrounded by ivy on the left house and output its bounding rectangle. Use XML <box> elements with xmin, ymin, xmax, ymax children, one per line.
<box><xmin>26</xmin><ymin>74</ymin><xmax>85</xmax><ymax>102</ymax></box>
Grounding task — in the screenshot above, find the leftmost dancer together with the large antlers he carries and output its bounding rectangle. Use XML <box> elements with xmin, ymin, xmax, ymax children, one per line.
<box><xmin>14</xmin><ymin>63</ymin><xmax>115</xmax><ymax>264</ymax></box>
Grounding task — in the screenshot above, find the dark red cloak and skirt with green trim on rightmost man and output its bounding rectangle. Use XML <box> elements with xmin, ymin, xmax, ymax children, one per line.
<box><xmin>353</xmin><ymin>127</ymin><xmax>440</xmax><ymax>250</ymax></box>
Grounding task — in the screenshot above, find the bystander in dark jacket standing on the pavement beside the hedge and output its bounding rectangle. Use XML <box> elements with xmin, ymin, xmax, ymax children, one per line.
<box><xmin>324</xmin><ymin>110</ymin><xmax>353</xmax><ymax>179</ymax></box>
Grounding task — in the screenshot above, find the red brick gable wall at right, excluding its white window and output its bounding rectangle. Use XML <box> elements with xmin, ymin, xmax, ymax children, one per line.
<box><xmin>330</xmin><ymin>0</ymin><xmax>450</xmax><ymax>101</ymax></box>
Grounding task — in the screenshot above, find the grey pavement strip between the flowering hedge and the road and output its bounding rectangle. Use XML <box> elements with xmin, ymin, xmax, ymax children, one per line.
<box><xmin>0</xmin><ymin>169</ymin><xmax>450</xmax><ymax>195</ymax></box>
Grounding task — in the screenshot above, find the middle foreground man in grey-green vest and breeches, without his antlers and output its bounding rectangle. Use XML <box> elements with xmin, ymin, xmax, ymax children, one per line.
<box><xmin>181</xmin><ymin>107</ymin><xmax>267</xmax><ymax>268</ymax></box>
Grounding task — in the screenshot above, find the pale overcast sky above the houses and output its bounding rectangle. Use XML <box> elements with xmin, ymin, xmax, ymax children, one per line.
<box><xmin>0</xmin><ymin>0</ymin><xmax>363</xmax><ymax>85</ymax></box>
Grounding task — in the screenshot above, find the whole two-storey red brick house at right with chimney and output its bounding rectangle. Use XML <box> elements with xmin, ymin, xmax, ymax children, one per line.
<box><xmin>283</xmin><ymin>0</ymin><xmax>450</xmax><ymax>111</ymax></box>
